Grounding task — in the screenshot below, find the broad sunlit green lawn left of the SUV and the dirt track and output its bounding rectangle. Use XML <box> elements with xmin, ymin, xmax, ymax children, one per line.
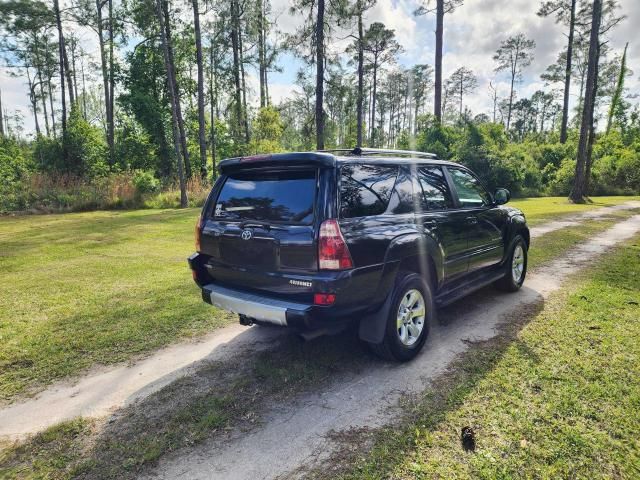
<box><xmin>0</xmin><ymin>209</ymin><xmax>231</xmax><ymax>400</ymax></box>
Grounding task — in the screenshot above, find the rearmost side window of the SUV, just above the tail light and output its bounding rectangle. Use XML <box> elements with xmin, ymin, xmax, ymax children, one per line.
<box><xmin>340</xmin><ymin>165</ymin><xmax>398</xmax><ymax>218</ymax></box>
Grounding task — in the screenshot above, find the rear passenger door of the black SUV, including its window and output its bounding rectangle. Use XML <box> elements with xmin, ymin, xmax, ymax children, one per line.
<box><xmin>415</xmin><ymin>165</ymin><xmax>467</xmax><ymax>283</ymax></box>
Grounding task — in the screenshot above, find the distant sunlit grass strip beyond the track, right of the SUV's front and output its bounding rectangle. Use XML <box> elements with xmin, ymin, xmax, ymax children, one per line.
<box><xmin>508</xmin><ymin>196</ymin><xmax>640</xmax><ymax>227</ymax></box>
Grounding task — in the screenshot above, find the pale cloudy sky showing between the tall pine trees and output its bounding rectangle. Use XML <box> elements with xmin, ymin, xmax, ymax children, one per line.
<box><xmin>0</xmin><ymin>0</ymin><xmax>640</xmax><ymax>133</ymax></box>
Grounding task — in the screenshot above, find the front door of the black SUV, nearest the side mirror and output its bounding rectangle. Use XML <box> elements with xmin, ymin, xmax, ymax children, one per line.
<box><xmin>447</xmin><ymin>167</ymin><xmax>506</xmax><ymax>272</ymax></box>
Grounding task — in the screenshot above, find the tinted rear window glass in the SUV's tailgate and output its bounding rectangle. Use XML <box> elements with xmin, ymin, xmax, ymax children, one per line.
<box><xmin>213</xmin><ymin>171</ymin><xmax>316</xmax><ymax>225</ymax></box>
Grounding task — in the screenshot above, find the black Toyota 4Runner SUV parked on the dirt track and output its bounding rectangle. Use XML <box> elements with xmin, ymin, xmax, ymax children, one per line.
<box><xmin>189</xmin><ymin>148</ymin><xmax>529</xmax><ymax>361</ymax></box>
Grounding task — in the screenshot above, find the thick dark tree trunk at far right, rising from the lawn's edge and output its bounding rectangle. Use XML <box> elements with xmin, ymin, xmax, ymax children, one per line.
<box><xmin>569</xmin><ymin>0</ymin><xmax>602</xmax><ymax>203</ymax></box>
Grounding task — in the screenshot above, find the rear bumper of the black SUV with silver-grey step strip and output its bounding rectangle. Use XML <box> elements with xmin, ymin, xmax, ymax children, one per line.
<box><xmin>202</xmin><ymin>284</ymin><xmax>314</xmax><ymax>327</ymax></box>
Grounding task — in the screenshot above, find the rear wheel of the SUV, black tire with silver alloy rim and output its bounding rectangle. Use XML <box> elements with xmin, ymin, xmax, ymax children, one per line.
<box><xmin>369</xmin><ymin>273</ymin><xmax>435</xmax><ymax>362</ymax></box>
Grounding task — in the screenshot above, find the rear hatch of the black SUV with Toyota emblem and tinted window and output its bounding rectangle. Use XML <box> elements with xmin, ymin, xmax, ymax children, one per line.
<box><xmin>200</xmin><ymin>167</ymin><xmax>319</xmax><ymax>300</ymax></box>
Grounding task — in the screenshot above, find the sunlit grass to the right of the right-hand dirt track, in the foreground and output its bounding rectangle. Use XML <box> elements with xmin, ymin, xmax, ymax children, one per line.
<box><xmin>330</xmin><ymin>237</ymin><xmax>640</xmax><ymax>479</ymax></box>
